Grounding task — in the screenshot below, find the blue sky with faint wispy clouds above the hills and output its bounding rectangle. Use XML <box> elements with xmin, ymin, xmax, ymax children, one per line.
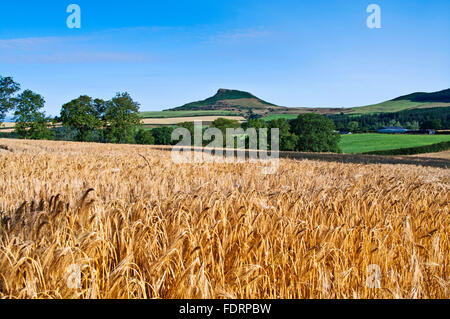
<box><xmin>0</xmin><ymin>0</ymin><xmax>450</xmax><ymax>115</ymax></box>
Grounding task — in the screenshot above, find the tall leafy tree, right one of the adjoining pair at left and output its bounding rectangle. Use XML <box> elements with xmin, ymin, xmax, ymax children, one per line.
<box><xmin>104</xmin><ymin>92</ymin><xmax>141</xmax><ymax>144</ymax></box>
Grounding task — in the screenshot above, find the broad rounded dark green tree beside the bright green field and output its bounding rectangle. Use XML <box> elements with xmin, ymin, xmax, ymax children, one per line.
<box><xmin>291</xmin><ymin>113</ymin><xmax>341</xmax><ymax>153</ymax></box>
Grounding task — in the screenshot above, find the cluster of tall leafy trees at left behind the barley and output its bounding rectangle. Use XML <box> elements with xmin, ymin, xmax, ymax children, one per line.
<box><xmin>0</xmin><ymin>76</ymin><xmax>148</xmax><ymax>143</ymax></box>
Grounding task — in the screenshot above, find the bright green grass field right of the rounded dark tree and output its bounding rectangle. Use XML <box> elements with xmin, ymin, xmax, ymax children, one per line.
<box><xmin>339</xmin><ymin>134</ymin><xmax>450</xmax><ymax>154</ymax></box>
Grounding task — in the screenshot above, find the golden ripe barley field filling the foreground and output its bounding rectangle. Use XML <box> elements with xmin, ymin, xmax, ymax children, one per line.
<box><xmin>0</xmin><ymin>139</ymin><xmax>450</xmax><ymax>299</ymax></box>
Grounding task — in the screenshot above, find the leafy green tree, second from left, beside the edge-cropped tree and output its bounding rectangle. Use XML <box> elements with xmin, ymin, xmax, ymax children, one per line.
<box><xmin>14</xmin><ymin>90</ymin><xmax>51</xmax><ymax>140</ymax></box>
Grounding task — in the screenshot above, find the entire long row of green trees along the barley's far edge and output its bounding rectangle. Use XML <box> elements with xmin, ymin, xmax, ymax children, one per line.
<box><xmin>0</xmin><ymin>76</ymin><xmax>340</xmax><ymax>152</ymax></box>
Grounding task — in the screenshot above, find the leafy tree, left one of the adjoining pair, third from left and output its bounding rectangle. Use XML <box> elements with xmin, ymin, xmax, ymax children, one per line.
<box><xmin>60</xmin><ymin>95</ymin><xmax>102</xmax><ymax>142</ymax></box>
